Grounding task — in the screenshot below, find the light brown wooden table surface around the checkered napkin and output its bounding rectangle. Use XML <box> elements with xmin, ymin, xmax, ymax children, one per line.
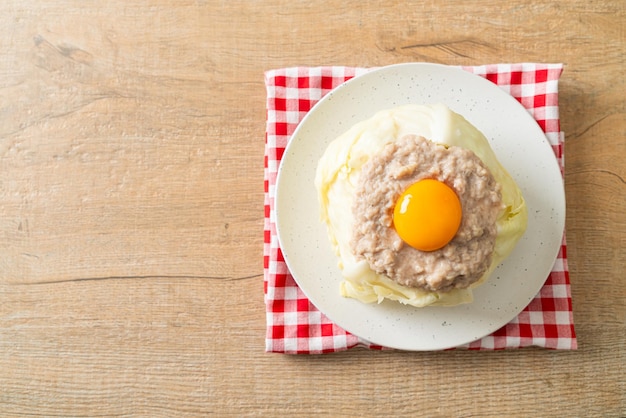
<box><xmin>0</xmin><ymin>0</ymin><xmax>626</xmax><ymax>417</ymax></box>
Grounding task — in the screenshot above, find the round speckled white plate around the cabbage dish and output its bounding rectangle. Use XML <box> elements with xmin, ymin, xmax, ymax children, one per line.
<box><xmin>276</xmin><ymin>63</ymin><xmax>565</xmax><ymax>350</ymax></box>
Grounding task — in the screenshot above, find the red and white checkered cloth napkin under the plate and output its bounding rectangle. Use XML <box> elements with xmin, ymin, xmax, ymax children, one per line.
<box><xmin>263</xmin><ymin>63</ymin><xmax>577</xmax><ymax>354</ymax></box>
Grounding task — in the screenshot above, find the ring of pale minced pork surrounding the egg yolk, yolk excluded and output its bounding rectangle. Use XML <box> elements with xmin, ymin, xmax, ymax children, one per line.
<box><xmin>350</xmin><ymin>135</ymin><xmax>502</xmax><ymax>292</ymax></box>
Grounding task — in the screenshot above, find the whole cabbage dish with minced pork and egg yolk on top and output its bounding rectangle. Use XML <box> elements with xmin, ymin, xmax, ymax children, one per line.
<box><xmin>315</xmin><ymin>104</ymin><xmax>527</xmax><ymax>307</ymax></box>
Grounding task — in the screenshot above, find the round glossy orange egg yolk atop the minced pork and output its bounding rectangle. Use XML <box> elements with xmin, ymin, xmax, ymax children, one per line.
<box><xmin>393</xmin><ymin>179</ymin><xmax>462</xmax><ymax>251</ymax></box>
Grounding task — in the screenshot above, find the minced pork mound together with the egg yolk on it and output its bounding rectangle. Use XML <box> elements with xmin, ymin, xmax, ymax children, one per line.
<box><xmin>350</xmin><ymin>135</ymin><xmax>503</xmax><ymax>292</ymax></box>
